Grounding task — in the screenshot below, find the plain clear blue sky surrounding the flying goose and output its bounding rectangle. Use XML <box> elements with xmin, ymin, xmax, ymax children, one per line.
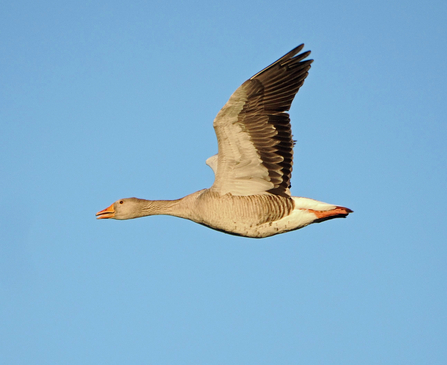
<box><xmin>0</xmin><ymin>0</ymin><xmax>447</xmax><ymax>365</ymax></box>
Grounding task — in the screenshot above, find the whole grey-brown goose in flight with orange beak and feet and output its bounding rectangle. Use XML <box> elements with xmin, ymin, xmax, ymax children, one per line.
<box><xmin>96</xmin><ymin>44</ymin><xmax>352</xmax><ymax>238</ymax></box>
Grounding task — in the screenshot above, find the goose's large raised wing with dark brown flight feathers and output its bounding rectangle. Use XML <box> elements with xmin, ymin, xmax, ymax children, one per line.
<box><xmin>211</xmin><ymin>44</ymin><xmax>313</xmax><ymax>196</ymax></box>
